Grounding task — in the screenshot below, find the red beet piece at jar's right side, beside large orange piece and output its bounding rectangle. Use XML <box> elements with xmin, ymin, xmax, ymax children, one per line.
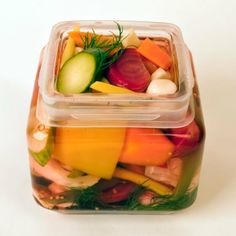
<box><xmin>170</xmin><ymin>121</ymin><xmax>200</xmax><ymax>156</ymax></box>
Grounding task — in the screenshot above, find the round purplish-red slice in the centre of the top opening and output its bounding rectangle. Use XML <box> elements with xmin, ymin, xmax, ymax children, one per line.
<box><xmin>107</xmin><ymin>48</ymin><xmax>150</xmax><ymax>92</ymax></box>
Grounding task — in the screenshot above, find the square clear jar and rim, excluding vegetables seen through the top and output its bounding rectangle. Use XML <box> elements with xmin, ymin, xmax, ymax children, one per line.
<box><xmin>27</xmin><ymin>21</ymin><xmax>205</xmax><ymax>214</ymax></box>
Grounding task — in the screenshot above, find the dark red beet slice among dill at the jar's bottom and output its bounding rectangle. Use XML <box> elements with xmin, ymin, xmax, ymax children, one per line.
<box><xmin>100</xmin><ymin>183</ymin><xmax>136</xmax><ymax>203</ymax></box>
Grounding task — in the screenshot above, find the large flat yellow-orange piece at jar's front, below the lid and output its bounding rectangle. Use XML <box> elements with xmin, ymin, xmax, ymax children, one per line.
<box><xmin>54</xmin><ymin>128</ymin><xmax>125</xmax><ymax>179</ymax></box>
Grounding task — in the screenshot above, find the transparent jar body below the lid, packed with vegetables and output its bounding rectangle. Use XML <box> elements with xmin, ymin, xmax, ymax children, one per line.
<box><xmin>27</xmin><ymin>22</ymin><xmax>205</xmax><ymax>214</ymax></box>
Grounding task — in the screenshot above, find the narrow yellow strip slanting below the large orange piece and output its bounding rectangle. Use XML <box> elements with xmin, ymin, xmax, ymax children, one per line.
<box><xmin>113</xmin><ymin>168</ymin><xmax>173</xmax><ymax>195</ymax></box>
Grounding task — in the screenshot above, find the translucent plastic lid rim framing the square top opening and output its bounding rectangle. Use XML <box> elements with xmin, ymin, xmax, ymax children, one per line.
<box><xmin>37</xmin><ymin>21</ymin><xmax>194</xmax><ymax>128</ymax></box>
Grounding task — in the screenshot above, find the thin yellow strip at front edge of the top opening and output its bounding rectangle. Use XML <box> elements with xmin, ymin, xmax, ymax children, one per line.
<box><xmin>90</xmin><ymin>81</ymin><xmax>134</xmax><ymax>94</ymax></box>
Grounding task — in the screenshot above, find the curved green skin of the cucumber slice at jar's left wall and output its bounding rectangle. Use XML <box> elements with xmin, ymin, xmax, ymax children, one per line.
<box><xmin>28</xmin><ymin>128</ymin><xmax>55</xmax><ymax>166</ymax></box>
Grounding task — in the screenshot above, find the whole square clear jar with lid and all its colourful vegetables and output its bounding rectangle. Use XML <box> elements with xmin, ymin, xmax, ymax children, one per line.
<box><xmin>27</xmin><ymin>21</ymin><xmax>205</xmax><ymax>213</ymax></box>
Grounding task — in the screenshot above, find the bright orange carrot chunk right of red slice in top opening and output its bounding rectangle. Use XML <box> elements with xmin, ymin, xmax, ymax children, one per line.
<box><xmin>137</xmin><ymin>38</ymin><xmax>171</xmax><ymax>70</ymax></box>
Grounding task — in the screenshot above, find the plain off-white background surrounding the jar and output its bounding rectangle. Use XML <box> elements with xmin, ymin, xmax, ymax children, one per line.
<box><xmin>0</xmin><ymin>0</ymin><xmax>236</xmax><ymax>236</ymax></box>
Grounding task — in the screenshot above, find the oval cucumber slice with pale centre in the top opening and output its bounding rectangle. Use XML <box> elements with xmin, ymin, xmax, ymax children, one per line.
<box><xmin>57</xmin><ymin>49</ymin><xmax>103</xmax><ymax>94</ymax></box>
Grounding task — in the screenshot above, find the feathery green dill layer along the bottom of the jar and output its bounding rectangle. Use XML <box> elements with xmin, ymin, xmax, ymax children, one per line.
<box><xmin>44</xmin><ymin>185</ymin><xmax>197</xmax><ymax>211</ymax></box>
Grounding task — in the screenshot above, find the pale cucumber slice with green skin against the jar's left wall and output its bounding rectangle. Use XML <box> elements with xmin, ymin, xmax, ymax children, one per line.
<box><xmin>27</xmin><ymin>107</ymin><xmax>55</xmax><ymax>166</ymax></box>
